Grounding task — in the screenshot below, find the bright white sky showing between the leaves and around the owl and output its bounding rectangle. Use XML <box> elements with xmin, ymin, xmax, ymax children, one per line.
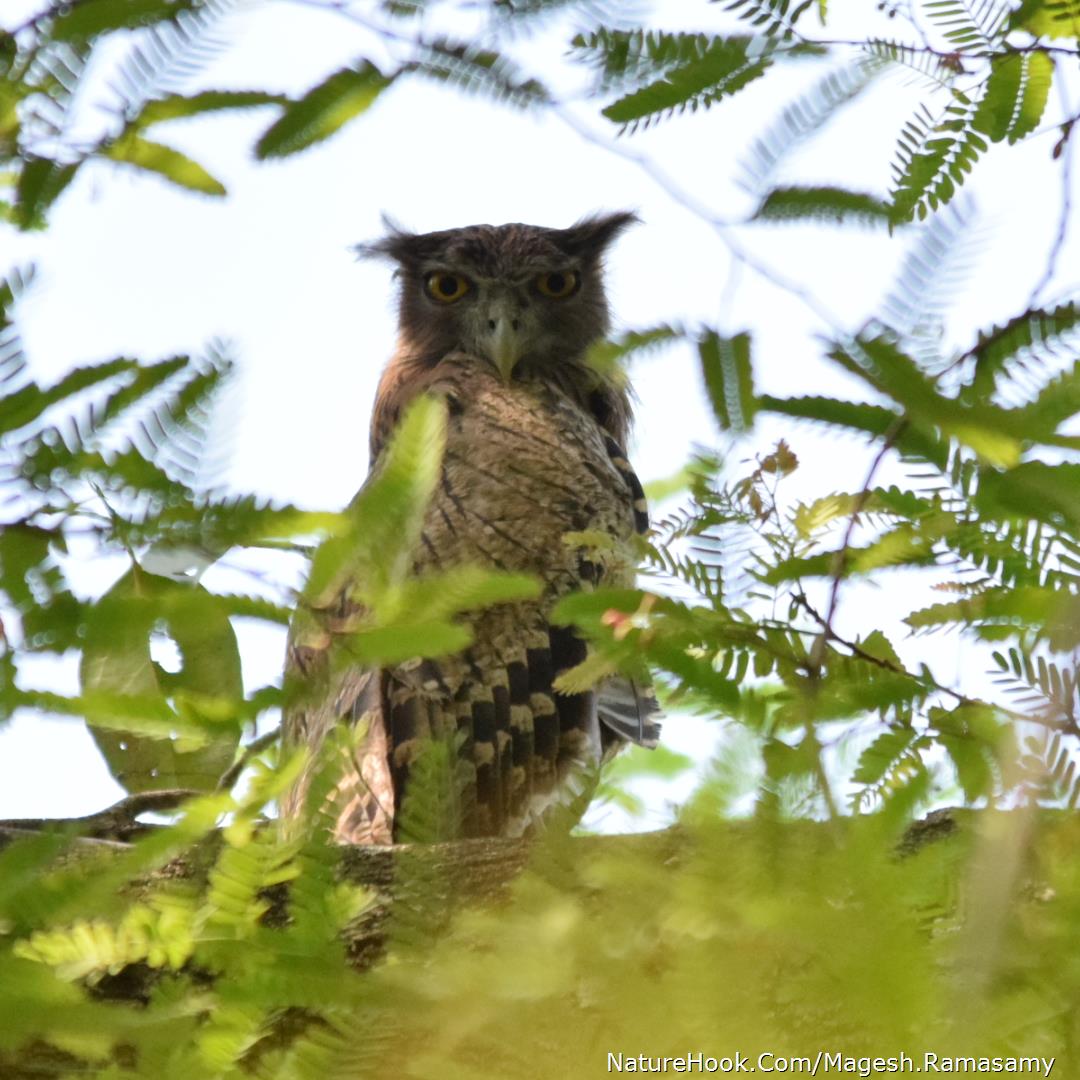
<box><xmin>0</xmin><ymin>0</ymin><xmax>1080</xmax><ymax>827</ymax></box>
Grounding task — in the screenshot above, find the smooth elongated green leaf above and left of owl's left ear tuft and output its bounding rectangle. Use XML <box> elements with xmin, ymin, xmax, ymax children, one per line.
<box><xmin>255</xmin><ymin>60</ymin><xmax>393</xmax><ymax>160</ymax></box>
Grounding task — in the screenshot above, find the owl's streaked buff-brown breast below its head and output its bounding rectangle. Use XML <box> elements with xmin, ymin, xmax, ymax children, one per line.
<box><xmin>417</xmin><ymin>363</ymin><xmax>634</xmax><ymax>598</ymax></box>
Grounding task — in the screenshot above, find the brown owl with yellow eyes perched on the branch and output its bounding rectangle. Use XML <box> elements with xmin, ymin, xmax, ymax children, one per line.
<box><xmin>283</xmin><ymin>213</ymin><xmax>659</xmax><ymax>843</ymax></box>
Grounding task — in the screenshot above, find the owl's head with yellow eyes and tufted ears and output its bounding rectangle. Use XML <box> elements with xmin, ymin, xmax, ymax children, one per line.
<box><xmin>360</xmin><ymin>213</ymin><xmax>636</xmax><ymax>382</ymax></box>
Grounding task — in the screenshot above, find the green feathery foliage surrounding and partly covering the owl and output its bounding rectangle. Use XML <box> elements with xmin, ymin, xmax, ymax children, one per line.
<box><xmin>0</xmin><ymin>0</ymin><xmax>1080</xmax><ymax>1080</ymax></box>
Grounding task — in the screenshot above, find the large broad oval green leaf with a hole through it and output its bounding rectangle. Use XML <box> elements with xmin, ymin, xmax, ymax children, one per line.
<box><xmin>80</xmin><ymin>566</ymin><xmax>243</xmax><ymax>792</ymax></box>
